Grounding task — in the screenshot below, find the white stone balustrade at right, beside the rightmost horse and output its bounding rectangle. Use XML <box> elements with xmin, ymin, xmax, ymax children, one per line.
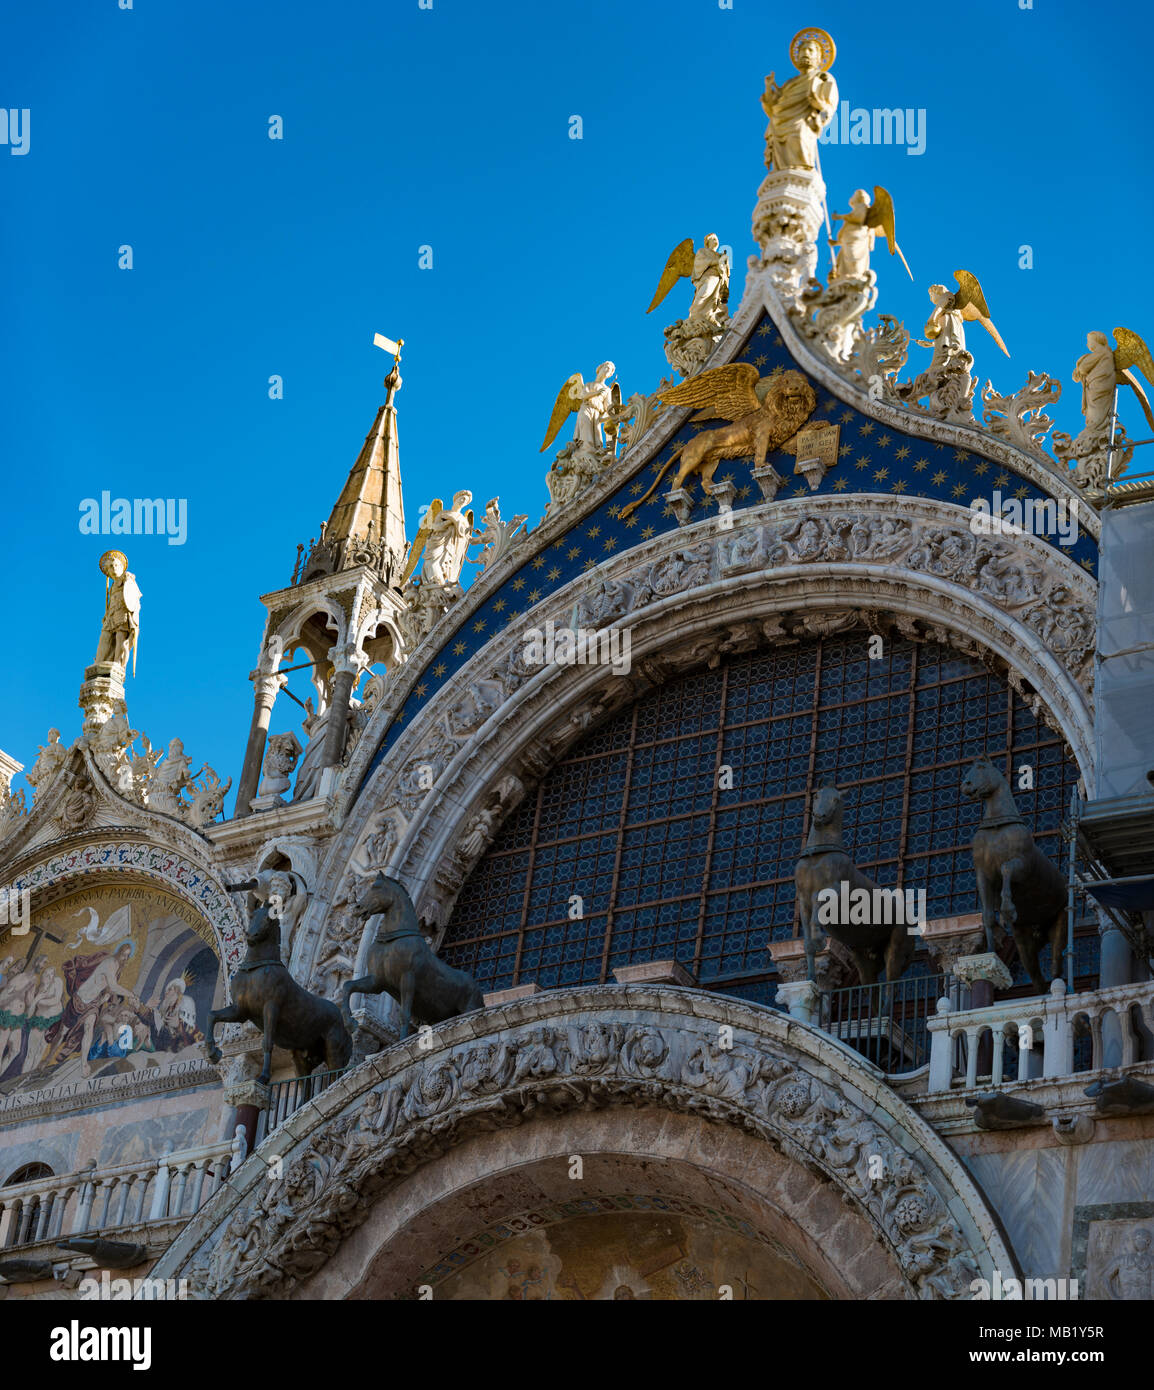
<box><xmin>929</xmin><ymin>980</ymin><xmax>1154</xmax><ymax>1093</ymax></box>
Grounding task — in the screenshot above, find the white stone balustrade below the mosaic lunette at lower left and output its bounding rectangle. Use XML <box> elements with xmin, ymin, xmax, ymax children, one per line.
<box><xmin>0</xmin><ymin>1126</ymin><xmax>245</xmax><ymax>1250</ymax></box>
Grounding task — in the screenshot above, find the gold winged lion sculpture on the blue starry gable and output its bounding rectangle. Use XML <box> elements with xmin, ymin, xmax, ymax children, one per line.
<box><xmin>621</xmin><ymin>361</ymin><xmax>818</xmax><ymax>517</ymax></box>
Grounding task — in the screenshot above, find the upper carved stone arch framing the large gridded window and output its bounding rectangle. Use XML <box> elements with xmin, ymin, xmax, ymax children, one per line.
<box><xmin>302</xmin><ymin>483</ymin><xmax>1096</xmax><ymax>995</ymax></box>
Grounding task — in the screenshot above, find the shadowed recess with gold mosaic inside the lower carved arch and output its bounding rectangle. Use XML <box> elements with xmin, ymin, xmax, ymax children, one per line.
<box><xmin>303</xmin><ymin>1105</ymin><xmax>889</xmax><ymax>1300</ymax></box>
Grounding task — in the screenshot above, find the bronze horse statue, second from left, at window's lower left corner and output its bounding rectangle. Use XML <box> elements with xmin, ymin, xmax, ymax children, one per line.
<box><xmin>342</xmin><ymin>873</ymin><xmax>485</xmax><ymax>1038</ymax></box>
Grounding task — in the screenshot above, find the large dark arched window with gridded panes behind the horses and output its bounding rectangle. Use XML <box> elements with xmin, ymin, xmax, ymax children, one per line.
<box><xmin>442</xmin><ymin>634</ymin><xmax>1078</xmax><ymax>1002</ymax></box>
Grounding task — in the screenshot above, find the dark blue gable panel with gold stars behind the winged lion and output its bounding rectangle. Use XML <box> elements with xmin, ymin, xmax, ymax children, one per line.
<box><xmin>360</xmin><ymin>316</ymin><xmax>1097</xmax><ymax>790</ymax></box>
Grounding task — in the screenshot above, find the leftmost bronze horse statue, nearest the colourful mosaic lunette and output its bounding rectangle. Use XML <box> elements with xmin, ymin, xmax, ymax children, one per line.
<box><xmin>209</xmin><ymin>902</ymin><xmax>353</xmax><ymax>1086</ymax></box>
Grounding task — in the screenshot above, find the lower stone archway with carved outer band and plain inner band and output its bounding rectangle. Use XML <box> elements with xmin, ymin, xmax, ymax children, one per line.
<box><xmin>153</xmin><ymin>986</ymin><xmax>1014</xmax><ymax>1298</ymax></box>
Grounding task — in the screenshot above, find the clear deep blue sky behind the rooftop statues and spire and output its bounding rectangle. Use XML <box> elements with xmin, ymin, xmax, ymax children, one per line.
<box><xmin>0</xmin><ymin>0</ymin><xmax>1154</xmax><ymax>806</ymax></box>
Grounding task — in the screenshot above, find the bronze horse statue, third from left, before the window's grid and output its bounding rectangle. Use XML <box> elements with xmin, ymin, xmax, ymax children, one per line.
<box><xmin>794</xmin><ymin>787</ymin><xmax>913</xmax><ymax>984</ymax></box>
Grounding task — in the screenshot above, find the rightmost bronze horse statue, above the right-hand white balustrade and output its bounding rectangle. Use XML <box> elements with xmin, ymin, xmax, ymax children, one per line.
<box><xmin>962</xmin><ymin>758</ymin><xmax>1066</xmax><ymax>994</ymax></box>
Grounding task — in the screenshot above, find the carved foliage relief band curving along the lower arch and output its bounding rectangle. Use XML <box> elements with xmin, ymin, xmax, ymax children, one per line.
<box><xmin>188</xmin><ymin>1017</ymin><xmax>979</xmax><ymax>1300</ymax></box>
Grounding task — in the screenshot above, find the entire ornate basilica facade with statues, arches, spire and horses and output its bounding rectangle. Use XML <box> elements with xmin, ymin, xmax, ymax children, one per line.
<box><xmin>0</xmin><ymin>31</ymin><xmax>1154</xmax><ymax>1301</ymax></box>
